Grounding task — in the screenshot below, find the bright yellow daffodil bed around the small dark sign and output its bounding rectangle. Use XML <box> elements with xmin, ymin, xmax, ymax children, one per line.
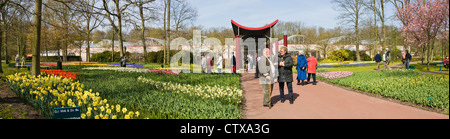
<box><xmin>7</xmin><ymin>73</ymin><xmax>140</xmax><ymax>119</ymax></box>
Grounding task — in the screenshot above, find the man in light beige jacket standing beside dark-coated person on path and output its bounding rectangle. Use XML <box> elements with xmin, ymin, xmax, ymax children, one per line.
<box><xmin>257</xmin><ymin>48</ymin><xmax>275</xmax><ymax>108</ymax></box>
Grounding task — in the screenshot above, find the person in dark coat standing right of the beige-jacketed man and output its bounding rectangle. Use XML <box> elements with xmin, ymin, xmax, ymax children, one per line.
<box><xmin>278</xmin><ymin>46</ymin><xmax>294</xmax><ymax>104</ymax></box>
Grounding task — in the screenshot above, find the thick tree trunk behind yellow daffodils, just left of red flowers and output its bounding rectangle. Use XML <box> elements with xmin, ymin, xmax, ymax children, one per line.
<box><xmin>31</xmin><ymin>0</ymin><xmax>42</xmax><ymax>76</ymax></box>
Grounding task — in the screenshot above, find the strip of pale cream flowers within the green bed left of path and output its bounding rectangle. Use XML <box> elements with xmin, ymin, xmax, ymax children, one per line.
<box><xmin>138</xmin><ymin>76</ymin><xmax>242</xmax><ymax>105</ymax></box>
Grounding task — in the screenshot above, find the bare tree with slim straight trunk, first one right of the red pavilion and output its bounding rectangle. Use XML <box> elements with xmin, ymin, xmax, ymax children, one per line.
<box><xmin>332</xmin><ymin>0</ymin><xmax>363</xmax><ymax>61</ymax></box>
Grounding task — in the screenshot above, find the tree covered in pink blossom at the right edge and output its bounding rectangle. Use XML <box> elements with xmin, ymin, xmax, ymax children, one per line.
<box><xmin>396</xmin><ymin>0</ymin><xmax>449</xmax><ymax>70</ymax></box>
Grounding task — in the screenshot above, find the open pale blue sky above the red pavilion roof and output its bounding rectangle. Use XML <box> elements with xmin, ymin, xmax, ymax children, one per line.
<box><xmin>190</xmin><ymin>0</ymin><xmax>400</xmax><ymax>28</ymax></box>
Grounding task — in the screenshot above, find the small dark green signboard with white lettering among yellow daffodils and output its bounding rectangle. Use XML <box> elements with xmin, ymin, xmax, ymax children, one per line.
<box><xmin>53</xmin><ymin>106</ymin><xmax>81</xmax><ymax>119</ymax></box>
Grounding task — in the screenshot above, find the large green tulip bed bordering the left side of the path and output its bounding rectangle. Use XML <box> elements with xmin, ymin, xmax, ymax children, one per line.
<box><xmin>64</xmin><ymin>67</ymin><xmax>243</xmax><ymax>119</ymax></box>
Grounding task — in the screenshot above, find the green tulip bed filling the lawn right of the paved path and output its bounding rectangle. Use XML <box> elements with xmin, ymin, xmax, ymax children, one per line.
<box><xmin>318</xmin><ymin>70</ymin><xmax>449</xmax><ymax>109</ymax></box>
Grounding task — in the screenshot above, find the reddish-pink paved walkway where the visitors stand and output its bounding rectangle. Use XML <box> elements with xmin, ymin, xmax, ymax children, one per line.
<box><xmin>241</xmin><ymin>73</ymin><xmax>449</xmax><ymax>119</ymax></box>
